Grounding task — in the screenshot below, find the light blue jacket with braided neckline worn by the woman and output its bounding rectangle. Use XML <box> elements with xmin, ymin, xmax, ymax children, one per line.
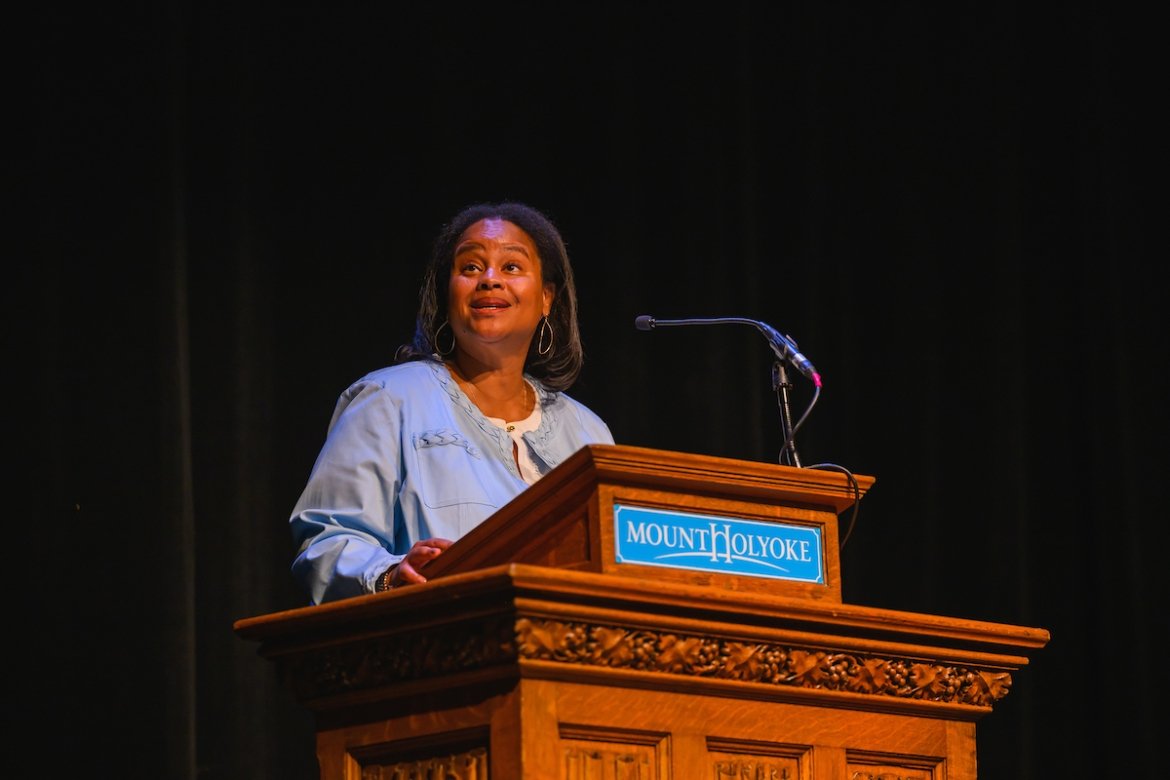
<box><xmin>289</xmin><ymin>360</ymin><xmax>613</xmax><ymax>603</ymax></box>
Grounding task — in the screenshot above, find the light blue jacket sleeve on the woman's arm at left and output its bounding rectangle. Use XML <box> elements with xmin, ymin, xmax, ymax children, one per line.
<box><xmin>290</xmin><ymin>380</ymin><xmax>402</xmax><ymax>605</ymax></box>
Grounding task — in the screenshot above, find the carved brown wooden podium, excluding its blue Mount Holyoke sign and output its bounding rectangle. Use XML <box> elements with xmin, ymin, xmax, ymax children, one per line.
<box><xmin>235</xmin><ymin>446</ymin><xmax>1048</xmax><ymax>780</ymax></box>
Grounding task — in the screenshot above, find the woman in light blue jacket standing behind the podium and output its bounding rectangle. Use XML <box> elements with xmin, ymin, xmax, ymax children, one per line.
<box><xmin>290</xmin><ymin>202</ymin><xmax>613</xmax><ymax>603</ymax></box>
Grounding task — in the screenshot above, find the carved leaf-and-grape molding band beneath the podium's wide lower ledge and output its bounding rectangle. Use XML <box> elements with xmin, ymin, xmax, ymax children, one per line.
<box><xmin>285</xmin><ymin>617</ymin><xmax>1012</xmax><ymax>706</ymax></box>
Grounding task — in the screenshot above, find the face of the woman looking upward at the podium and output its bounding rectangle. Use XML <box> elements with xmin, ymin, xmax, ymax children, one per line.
<box><xmin>447</xmin><ymin>219</ymin><xmax>556</xmax><ymax>358</ymax></box>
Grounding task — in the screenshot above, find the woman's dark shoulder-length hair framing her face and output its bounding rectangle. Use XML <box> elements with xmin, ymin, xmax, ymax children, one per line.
<box><xmin>397</xmin><ymin>202</ymin><xmax>584</xmax><ymax>391</ymax></box>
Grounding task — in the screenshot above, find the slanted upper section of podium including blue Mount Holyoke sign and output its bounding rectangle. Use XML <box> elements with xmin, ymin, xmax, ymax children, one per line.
<box><xmin>422</xmin><ymin>444</ymin><xmax>874</xmax><ymax>601</ymax></box>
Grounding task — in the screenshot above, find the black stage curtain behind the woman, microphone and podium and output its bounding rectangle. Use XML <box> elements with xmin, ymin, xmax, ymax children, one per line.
<box><xmin>22</xmin><ymin>0</ymin><xmax>1166</xmax><ymax>780</ymax></box>
